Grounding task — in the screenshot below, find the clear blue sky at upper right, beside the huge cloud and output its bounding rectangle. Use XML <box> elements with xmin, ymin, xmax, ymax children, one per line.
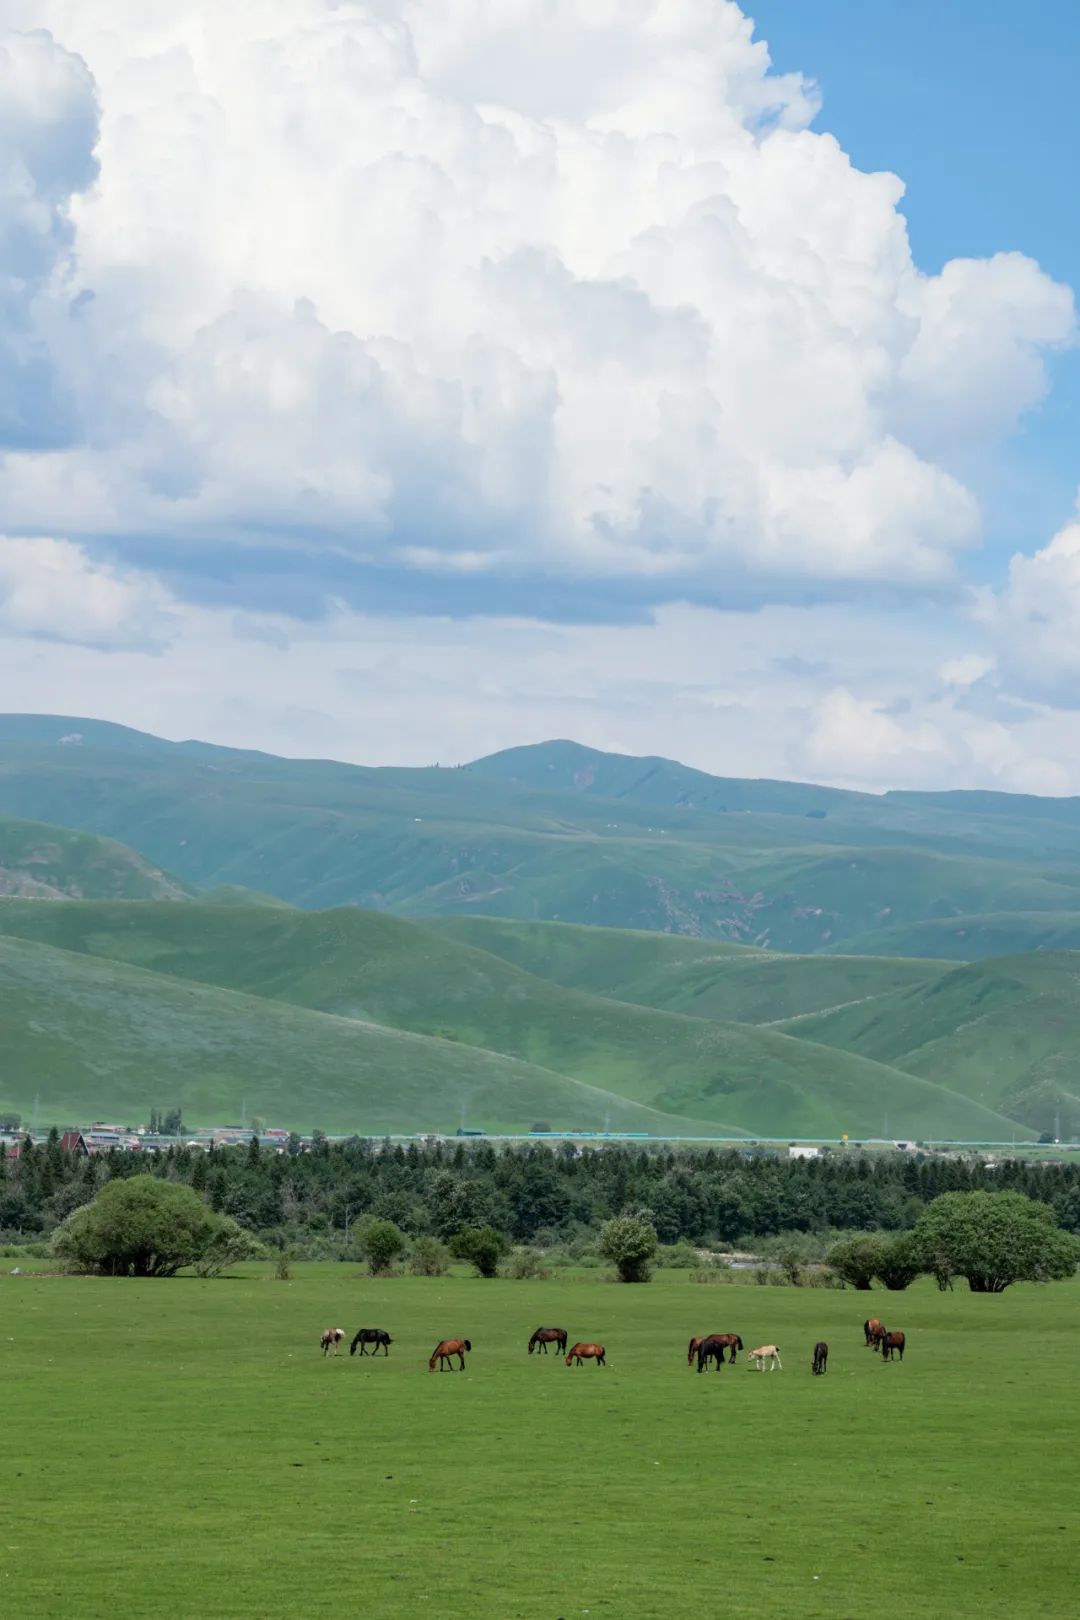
<box><xmin>751</xmin><ymin>0</ymin><xmax>1080</xmax><ymax>577</ymax></box>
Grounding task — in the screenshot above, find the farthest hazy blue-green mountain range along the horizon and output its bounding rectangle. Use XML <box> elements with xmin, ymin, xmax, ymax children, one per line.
<box><xmin>0</xmin><ymin>716</ymin><xmax>1080</xmax><ymax>954</ymax></box>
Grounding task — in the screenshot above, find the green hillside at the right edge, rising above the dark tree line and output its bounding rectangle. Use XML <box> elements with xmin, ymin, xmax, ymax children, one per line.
<box><xmin>785</xmin><ymin>951</ymin><xmax>1080</xmax><ymax>1137</ymax></box>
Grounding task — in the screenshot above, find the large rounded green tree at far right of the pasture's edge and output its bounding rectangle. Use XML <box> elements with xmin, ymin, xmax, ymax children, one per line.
<box><xmin>912</xmin><ymin>1192</ymin><xmax>1080</xmax><ymax>1294</ymax></box>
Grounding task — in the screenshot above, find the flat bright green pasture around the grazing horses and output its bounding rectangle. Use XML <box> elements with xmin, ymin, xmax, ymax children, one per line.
<box><xmin>0</xmin><ymin>1262</ymin><xmax>1080</xmax><ymax>1620</ymax></box>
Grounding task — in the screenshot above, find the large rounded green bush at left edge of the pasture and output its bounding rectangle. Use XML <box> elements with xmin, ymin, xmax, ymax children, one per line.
<box><xmin>53</xmin><ymin>1176</ymin><xmax>222</xmax><ymax>1277</ymax></box>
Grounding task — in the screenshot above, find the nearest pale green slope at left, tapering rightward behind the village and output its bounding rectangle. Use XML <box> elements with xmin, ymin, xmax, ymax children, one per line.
<box><xmin>0</xmin><ymin>933</ymin><xmax>712</xmax><ymax>1136</ymax></box>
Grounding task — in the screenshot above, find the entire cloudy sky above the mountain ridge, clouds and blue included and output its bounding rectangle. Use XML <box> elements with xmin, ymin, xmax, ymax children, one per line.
<box><xmin>0</xmin><ymin>0</ymin><xmax>1080</xmax><ymax>792</ymax></box>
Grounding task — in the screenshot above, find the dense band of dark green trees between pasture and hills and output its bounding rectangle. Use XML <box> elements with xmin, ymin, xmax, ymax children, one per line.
<box><xmin>0</xmin><ymin>1136</ymin><xmax>1080</xmax><ymax>1256</ymax></box>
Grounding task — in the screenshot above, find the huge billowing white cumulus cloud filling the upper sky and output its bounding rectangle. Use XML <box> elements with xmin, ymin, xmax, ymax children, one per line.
<box><xmin>0</xmin><ymin>0</ymin><xmax>1074</xmax><ymax>595</ymax></box>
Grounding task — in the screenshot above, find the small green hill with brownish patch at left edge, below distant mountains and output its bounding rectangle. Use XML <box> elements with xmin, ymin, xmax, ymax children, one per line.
<box><xmin>0</xmin><ymin>818</ymin><xmax>191</xmax><ymax>901</ymax></box>
